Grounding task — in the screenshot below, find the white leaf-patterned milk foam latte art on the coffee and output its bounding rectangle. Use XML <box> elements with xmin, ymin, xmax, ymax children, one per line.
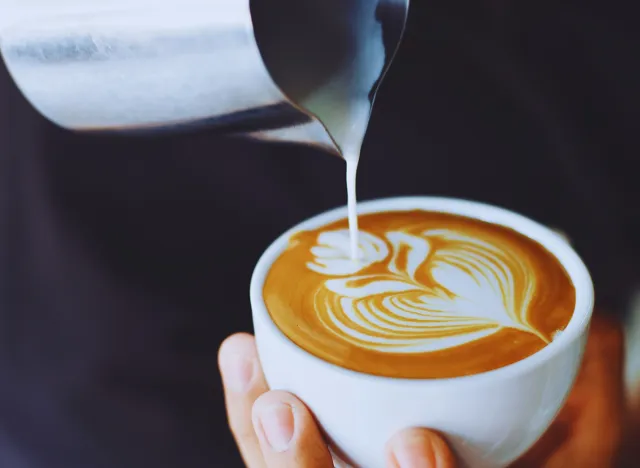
<box><xmin>307</xmin><ymin>229</ymin><xmax>549</xmax><ymax>353</ymax></box>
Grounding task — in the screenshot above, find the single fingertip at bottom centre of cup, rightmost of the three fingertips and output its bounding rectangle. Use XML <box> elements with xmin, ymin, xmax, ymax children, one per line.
<box><xmin>387</xmin><ymin>429</ymin><xmax>456</xmax><ymax>468</ymax></box>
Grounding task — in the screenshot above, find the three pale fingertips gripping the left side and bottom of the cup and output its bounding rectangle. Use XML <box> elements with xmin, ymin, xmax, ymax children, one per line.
<box><xmin>219</xmin><ymin>334</ymin><xmax>455</xmax><ymax>468</ymax></box>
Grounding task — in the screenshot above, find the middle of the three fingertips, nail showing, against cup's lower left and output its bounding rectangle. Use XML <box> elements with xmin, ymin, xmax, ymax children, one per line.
<box><xmin>252</xmin><ymin>391</ymin><xmax>333</xmax><ymax>468</ymax></box>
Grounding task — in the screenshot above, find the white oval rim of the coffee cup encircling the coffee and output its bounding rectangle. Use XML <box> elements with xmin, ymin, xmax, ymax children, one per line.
<box><xmin>250</xmin><ymin>196</ymin><xmax>594</xmax><ymax>386</ymax></box>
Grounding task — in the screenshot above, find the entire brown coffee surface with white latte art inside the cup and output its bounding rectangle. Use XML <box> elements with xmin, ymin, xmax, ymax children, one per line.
<box><xmin>263</xmin><ymin>210</ymin><xmax>575</xmax><ymax>378</ymax></box>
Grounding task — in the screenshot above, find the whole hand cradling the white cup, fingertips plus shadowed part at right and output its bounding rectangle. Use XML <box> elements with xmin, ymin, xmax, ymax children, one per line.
<box><xmin>219</xmin><ymin>317</ymin><xmax>625</xmax><ymax>468</ymax></box>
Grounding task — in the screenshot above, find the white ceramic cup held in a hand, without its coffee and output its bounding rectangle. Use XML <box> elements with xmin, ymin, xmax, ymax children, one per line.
<box><xmin>251</xmin><ymin>197</ymin><xmax>594</xmax><ymax>468</ymax></box>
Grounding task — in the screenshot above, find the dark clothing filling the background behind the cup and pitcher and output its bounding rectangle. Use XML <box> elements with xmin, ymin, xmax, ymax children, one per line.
<box><xmin>0</xmin><ymin>0</ymin><xmax>640</xmax><ymax>468</ymax></box>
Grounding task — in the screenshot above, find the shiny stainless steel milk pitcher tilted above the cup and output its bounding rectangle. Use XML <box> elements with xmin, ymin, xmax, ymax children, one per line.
<box><xmin>0</xmin><ymin>0</ymin><xmax>409</xmax><ymax>153</ymax></box>
